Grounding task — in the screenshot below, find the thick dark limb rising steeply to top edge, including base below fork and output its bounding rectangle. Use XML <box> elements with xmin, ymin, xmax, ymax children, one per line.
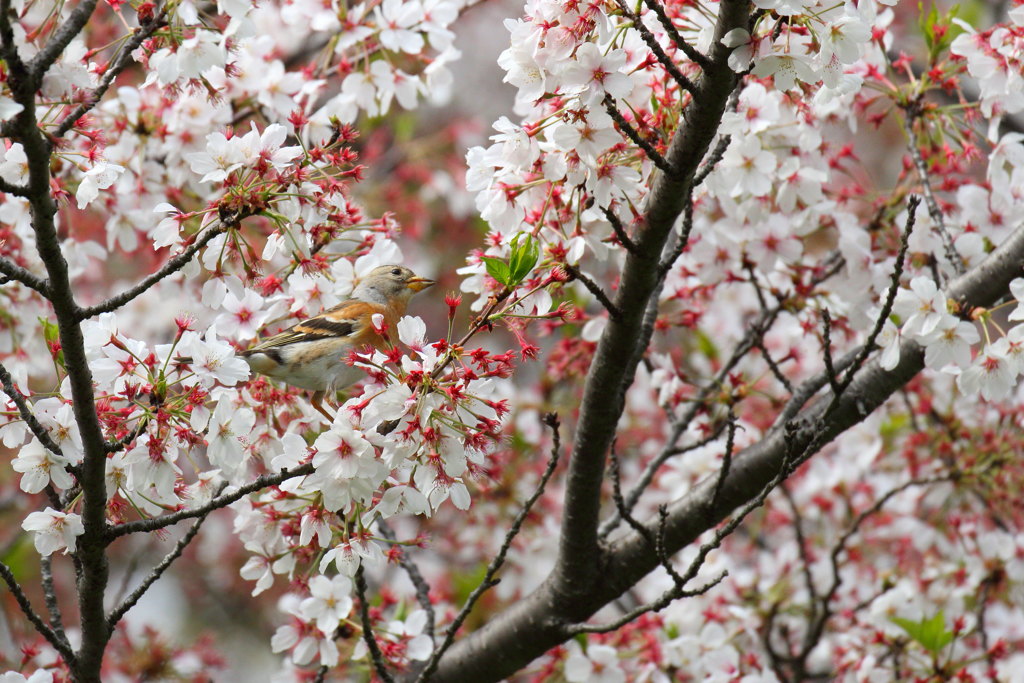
<box><xmin>419</xmin><ymin>0</ymin><xmax>750</xmax><ymax>681</ymax></box>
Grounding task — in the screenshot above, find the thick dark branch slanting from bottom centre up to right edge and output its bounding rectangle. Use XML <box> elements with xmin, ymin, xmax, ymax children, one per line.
<box><xmin>423</xmin><ymin>152</ymin><xmax>1024</xmax><ymax>681</ymax></box>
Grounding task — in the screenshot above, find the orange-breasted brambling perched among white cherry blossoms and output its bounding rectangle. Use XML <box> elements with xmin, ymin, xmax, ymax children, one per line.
<box><xmin>242</xmin><ymin>265</ymin><xmax>434</xmax><ymax>421</ymax></box>
